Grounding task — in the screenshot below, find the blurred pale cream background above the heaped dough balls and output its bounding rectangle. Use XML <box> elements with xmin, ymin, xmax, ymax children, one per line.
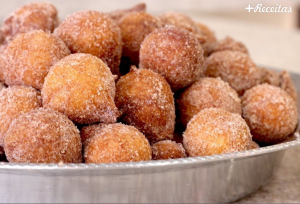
<box><xmin>0</xmin><ymin>0</ymin><xmax>300</xmax><ymax>73</ymax></box>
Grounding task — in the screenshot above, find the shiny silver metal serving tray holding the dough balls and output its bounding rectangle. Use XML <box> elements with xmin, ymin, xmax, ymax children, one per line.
<box><xmin>0</xmin><ymin>71</ymin><xmax>300</xmax><ymax>203</ymax></box>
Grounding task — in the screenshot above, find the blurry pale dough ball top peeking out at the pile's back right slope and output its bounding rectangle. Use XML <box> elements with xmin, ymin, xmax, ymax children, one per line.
<box><xmin>213</xmin><ymin>36</ymin><xmax>249</xmax><ymax>54</ymax></box>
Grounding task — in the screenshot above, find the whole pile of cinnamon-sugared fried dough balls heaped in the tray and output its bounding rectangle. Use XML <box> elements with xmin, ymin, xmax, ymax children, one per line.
<box><xmin>0</xmin><ymin>2</ymin><xmax>298</xmax><ymax>163</ymax></box>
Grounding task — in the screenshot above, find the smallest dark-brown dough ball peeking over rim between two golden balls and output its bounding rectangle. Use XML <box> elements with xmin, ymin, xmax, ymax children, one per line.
<box><xmin>152</xmin><ymin>140</ymin><xmax>186</xmax><ymax>160</ymax></box>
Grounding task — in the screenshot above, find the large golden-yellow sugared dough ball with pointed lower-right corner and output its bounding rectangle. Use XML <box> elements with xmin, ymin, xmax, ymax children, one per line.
<box><xmin>42</xmin><ymin>53</ymin><xmax>118</xmax><ymax>124</ymax></box>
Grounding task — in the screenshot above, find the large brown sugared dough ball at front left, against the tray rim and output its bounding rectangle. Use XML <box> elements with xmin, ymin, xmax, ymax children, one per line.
<box><xmin>4</xmin><ymin>108</ymin><xmax>82</xmax><ymax>163</ymax></box>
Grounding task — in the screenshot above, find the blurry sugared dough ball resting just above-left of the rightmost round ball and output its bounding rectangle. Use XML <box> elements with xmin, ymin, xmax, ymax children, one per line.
<box><xmin>205</xmin><ymin>50</ymin><xmax>261</xmax><ymax>95</ymax></box>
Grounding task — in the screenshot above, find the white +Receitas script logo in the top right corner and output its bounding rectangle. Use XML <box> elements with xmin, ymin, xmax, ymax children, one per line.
<box><xmin>245</xmin><ymin>4</ymin><xmax>292</xmax><ymax>13</ymax></box>
